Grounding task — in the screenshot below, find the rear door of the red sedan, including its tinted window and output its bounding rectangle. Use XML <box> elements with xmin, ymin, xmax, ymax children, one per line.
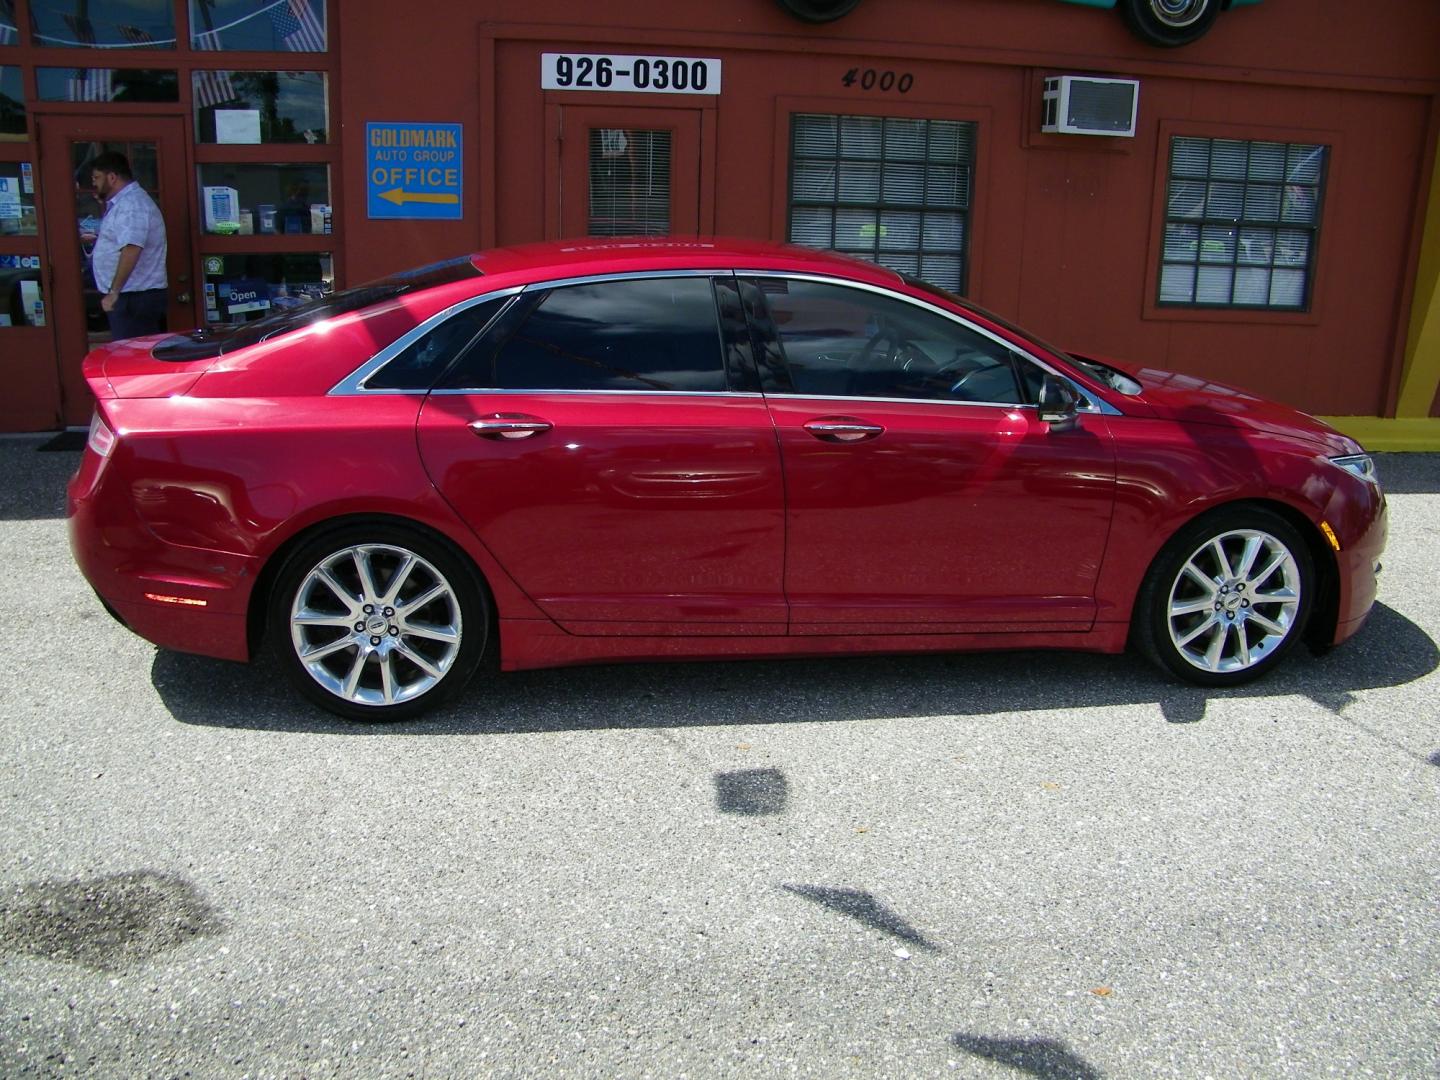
<box><xmin>419</xmin><ymin>274</ymin><xmax>786</xmax><ymax>635</ymax></box>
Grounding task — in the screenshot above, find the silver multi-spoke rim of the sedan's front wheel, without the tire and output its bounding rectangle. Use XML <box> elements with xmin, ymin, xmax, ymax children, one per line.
<box><xmin>1166</xmin><ymin>528</ymin><xmax>1300</xmax><ymax>672</ymax></box>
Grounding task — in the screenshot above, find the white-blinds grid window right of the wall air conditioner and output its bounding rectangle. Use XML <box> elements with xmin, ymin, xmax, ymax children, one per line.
<box><xmin>1159</xmin><ymin>137</ymin><xmax>1329</xmax><ymax>311</ymax></box>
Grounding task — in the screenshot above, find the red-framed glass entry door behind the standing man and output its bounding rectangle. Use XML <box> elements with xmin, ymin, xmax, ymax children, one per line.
<box><xmin>39</xmin><ymin>117</ymin><xmax>196</xmax><ymax>425</ymax></box>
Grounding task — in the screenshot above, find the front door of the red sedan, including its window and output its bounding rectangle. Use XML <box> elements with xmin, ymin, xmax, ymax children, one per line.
<box><xmin>742</xmin><ymin>276</ymin><xmax>1115</xmax><ymax>634</ymax></box>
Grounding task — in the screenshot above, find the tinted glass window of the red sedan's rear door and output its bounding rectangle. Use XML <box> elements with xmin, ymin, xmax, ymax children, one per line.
<box><xmin>494</xmin><ymin>278</ymin><xmax>726</xmax><ymax>392</ymax></box>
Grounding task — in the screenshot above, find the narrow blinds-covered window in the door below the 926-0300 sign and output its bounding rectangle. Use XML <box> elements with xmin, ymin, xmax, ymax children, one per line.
<box><xmin>589</xmin><ymin>128</ymin><xmax>671</xmax><ymax>236</ymax></box>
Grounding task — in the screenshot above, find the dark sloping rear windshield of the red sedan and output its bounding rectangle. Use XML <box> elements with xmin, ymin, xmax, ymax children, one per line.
<box><xmin>153</xmin><ymin>255</ymin><xmax>481</xmax><ymax>361</ymax></box>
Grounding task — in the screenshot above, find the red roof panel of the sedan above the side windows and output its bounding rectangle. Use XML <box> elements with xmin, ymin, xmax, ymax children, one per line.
<box><xmin>471</xmin><ymin>236</ymin><xmax>900</xmax><ymax>287</ymax></box>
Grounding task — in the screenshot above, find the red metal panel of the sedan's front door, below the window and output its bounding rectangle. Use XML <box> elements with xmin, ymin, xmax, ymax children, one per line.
<box><xmin>769</xmin><ymin>397</ymin><xmax>1115</xmax><ymax>634</ymax></box>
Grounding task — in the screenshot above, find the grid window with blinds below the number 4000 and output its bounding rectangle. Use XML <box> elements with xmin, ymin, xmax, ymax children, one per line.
<box><xmin>789</xmin><ymin>112</ymin><xmax>975</xmax><ymax>292</ymax></box>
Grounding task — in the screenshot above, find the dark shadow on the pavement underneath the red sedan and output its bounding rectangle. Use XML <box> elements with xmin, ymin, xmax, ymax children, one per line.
<box><xmin>151</xmin><ymin>603</ymin><xmax>1440</xmax><ymax>753</ymax></box>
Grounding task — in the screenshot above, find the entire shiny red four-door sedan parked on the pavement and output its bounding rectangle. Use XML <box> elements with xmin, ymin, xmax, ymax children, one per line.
<box><xmin>69</xmin><ymin>240</ymin><xmax>1385</xmax><ymax>719</ymax></box>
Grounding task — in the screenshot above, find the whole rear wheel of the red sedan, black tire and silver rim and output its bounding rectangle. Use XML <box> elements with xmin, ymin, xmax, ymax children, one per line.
<box><xmin>269</xmin><ymin>521</ymin><xmax>491</xmax><ymax>720</ymax></box>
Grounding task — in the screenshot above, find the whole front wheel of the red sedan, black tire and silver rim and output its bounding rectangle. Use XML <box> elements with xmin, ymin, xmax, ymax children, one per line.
<box><xmin>1132</xmin><ymin>507</ymin><xmax>1316</xmax><ymax>687</ymax></box>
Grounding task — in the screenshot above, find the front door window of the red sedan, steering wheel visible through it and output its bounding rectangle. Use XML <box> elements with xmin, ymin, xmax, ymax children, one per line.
<box><xmin>755</xmin><ymin>278</ymin><xmax>1025</xmax><ymax>405</ymax></box>
